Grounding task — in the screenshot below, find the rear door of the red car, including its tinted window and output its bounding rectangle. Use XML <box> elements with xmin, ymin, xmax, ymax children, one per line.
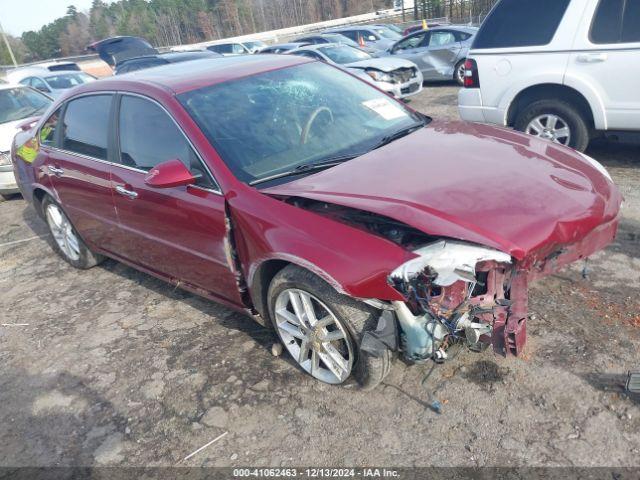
<box><xmin>39</xmin><ymin>94</ymin><xmax>118</xmax><ymax>251</ymax></box>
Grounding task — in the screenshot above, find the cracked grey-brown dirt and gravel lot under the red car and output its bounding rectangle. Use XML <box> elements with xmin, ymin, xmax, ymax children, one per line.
<box><xmin>0</xmin><ymin>85</ymin><xmax>640</xmax><ymax>467</ymax></box>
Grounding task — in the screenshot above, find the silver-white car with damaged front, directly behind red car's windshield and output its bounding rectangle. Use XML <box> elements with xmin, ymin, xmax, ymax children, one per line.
<box><xmin>289</xmin><ymin>43</ymin><xmax>422</xmax><ymax>99</ymax></box>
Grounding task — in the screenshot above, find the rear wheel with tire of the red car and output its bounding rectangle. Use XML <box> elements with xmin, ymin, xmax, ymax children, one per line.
<box><xmin>42</xmin><ymin>195</ymin><xmax>104</xmax><ymax>270</ymax></box>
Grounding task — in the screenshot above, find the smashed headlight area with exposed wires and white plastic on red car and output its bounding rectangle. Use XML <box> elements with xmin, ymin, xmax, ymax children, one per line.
<box><xmin>389</xmin><ymin>240</ymin><xmax>516</xmax><ymax>362</ymax></box>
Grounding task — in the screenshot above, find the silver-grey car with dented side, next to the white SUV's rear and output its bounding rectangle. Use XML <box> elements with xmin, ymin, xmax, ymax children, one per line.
<box><xmin>385</xmin><ymin>25</ymin><xmax>478</xmax><ymax>85</ymax></box>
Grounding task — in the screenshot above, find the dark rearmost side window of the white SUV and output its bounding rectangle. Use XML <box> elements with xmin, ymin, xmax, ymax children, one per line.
<box><xmin>473</xmin><ymin>0</ymin><xmax>570</xmax><ymax>49</ymax></box>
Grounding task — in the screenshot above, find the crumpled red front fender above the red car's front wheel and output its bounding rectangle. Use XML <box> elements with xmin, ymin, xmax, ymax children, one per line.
<box><xmin>227</xmin><ymin>188</ymin><xmax>414</xmax><ymax>301</ymax></box>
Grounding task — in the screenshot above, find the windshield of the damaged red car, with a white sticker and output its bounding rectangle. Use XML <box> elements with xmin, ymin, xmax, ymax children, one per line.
<box><xmin>178</xmin><ymin>62</ymin><xmax>424</xmax><ymax>183</ymax></box>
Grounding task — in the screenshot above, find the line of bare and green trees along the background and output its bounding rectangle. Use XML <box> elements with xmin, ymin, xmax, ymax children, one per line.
<box><xmin>0</xmin><ymin>0</ymin><xmax>495</xmax><ymax>65</ymax></box>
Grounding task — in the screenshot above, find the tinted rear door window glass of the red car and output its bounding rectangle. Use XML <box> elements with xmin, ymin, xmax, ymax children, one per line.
<box><xmin>62</xmin><ymin>95</ymin><xmax>112</xmax><ymax>160</ymax></box>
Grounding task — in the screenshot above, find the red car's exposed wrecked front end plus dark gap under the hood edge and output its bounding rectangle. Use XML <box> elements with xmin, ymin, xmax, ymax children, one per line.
<box><xmin>286</xmin><ymin>197</ymin><xmax>527</xmax><ymax>362</ymax></box>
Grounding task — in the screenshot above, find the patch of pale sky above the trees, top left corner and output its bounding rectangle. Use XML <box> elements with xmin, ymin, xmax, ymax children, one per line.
<box><xmin>0</xmin><ymin>0</ymin><xmax>114</xmax><ymax>37</ymax></box>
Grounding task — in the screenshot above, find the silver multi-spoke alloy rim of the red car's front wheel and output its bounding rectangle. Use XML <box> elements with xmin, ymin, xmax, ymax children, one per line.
<box><xmin>275</xmin><ymin>288</ymin><xmax>354</xmax><ymax>384</ymax></box>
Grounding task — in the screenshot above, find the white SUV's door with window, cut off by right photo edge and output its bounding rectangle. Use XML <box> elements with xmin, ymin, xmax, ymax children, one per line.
<box><xmin>568</xmin><ymin>0</ymin><xmax>640</xmax><ymax>130</ymax></box>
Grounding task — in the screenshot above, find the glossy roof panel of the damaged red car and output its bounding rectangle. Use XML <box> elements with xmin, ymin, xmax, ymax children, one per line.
<box><xmin>81</xmin><ymin>54</ymin><xmax>312</xmax><ymax>94</ymax></box>
